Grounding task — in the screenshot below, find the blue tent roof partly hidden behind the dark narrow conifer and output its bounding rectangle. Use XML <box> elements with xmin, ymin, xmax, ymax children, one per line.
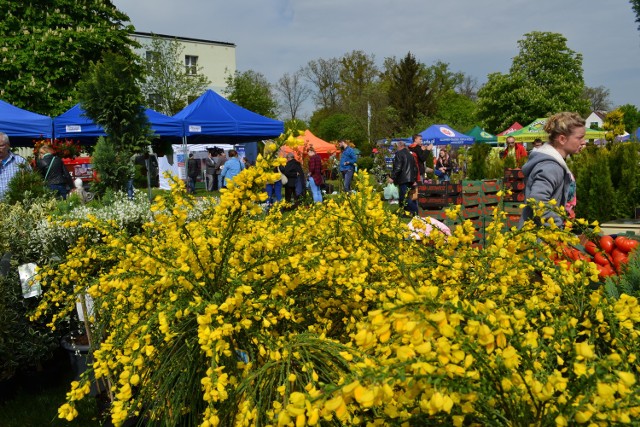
<box><xmin>53</xmin><ymin>104</ymin><xmax>182</xmax><ymax>139</ymax></box>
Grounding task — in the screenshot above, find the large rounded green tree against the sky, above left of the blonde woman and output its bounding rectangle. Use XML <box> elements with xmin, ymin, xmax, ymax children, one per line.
<box><xmin>478</xmin><ymin>31</ymin><xmax>589</xmax><ymax>130</ymax></box>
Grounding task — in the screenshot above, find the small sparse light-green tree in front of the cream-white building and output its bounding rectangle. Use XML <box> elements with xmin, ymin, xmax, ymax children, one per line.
<box><xmin>142</xmin><ymin>35</ymin><xmax>211</xmax><ymax>116</ymax></box>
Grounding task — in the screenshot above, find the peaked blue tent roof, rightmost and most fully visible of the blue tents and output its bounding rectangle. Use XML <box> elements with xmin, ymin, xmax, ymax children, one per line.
<box><xmin>173</xmin><ymin>89</ymin><xmax>284</xmax><ymax>143</ymax></box>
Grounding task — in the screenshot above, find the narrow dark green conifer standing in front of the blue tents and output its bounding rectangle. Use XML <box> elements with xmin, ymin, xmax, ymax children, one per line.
<box><xmin>78</xmin><ymin>53</ymin><xmax>151</xmax><ymax>193</ymax></box>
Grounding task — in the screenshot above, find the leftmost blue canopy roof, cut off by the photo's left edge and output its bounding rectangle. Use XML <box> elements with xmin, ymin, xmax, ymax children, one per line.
<box><xmin>0</xmin><ymin>100</ymin><xmax>53</xmax><ymax>147</ymax></box>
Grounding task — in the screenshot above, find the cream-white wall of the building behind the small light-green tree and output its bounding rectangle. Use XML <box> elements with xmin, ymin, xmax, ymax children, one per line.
<box><xmin>132</xmin><ymin>32</ymin><xmax>236</xmax><ymax>96</ymax></box>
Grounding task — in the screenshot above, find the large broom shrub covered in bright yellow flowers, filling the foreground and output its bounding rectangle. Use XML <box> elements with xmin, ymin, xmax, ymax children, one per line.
<box><xmin>34</xmin><ymin>132</ymin><xmax>640</xmax><ymax>427</ymax></box>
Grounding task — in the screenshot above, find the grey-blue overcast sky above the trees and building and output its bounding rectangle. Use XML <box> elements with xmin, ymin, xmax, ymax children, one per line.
<box><xmin>113</xmin><ymin>0</ymin><xmax>640</xmax><ymax>115</ymax></box>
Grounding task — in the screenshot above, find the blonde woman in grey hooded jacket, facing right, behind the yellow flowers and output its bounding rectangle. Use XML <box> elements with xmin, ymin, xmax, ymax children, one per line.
<box><xmin>520</xmin><ymin>112</ymin><xmax>586</xmax><ymax>227</ymax></box>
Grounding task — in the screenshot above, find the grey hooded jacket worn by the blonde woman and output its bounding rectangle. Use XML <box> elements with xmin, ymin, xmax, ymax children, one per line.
<box><xmin>519</xmin><ymin>143</ymin><xmax>573</xmax><ymax>231</ymax></box>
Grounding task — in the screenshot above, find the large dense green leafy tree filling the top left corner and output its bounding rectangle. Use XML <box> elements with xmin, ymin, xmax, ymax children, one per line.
<box><xmin>0</xmin><ymin>0</ymin><xmax>135</xmax><ymax>116</ymax></box>
